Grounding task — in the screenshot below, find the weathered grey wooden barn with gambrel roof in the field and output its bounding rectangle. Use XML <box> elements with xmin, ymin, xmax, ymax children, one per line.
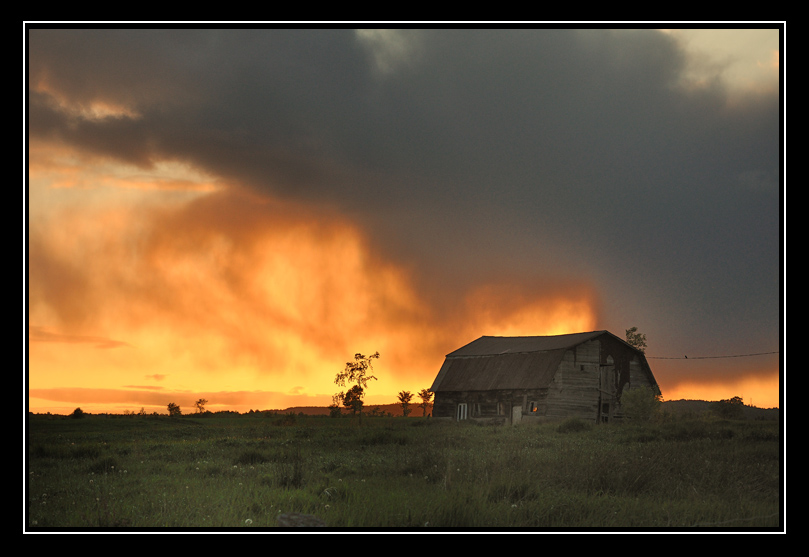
<box><xmin>430</xmin><ymin>331</ymin><xmax>660</xmax><ymax>423</ymax></box>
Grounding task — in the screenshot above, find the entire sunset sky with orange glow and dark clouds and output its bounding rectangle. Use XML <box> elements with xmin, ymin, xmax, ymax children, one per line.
<box><xmin>24</xmin><ymin>25</ymin><xmax>785</xmax><ymax>413</ymax></box>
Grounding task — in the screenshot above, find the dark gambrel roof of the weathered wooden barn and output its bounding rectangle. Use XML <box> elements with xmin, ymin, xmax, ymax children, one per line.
<box><xmin>430</xmin><ymin>331</ymin><xmax>636</xmax><ymax>392</ymax></box>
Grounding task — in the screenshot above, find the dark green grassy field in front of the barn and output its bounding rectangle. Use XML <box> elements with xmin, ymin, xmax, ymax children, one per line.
<box><xmin>24</xmin><ymin>415</ymin><xmax>783</xmax><ymax>531</ymax></box>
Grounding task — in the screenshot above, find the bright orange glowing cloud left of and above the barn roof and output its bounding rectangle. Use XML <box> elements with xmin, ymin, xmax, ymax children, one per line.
<box><xmin>29</xmin><ymin>179</ymin><xmax>597</xmax><ymax>408</ymax></box>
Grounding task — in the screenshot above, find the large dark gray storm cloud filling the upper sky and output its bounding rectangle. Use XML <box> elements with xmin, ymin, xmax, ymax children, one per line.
<box><xmin>29</xmin><ymin>29</ymin><xmax>781</xmax><ymax>378</ymax></box>
